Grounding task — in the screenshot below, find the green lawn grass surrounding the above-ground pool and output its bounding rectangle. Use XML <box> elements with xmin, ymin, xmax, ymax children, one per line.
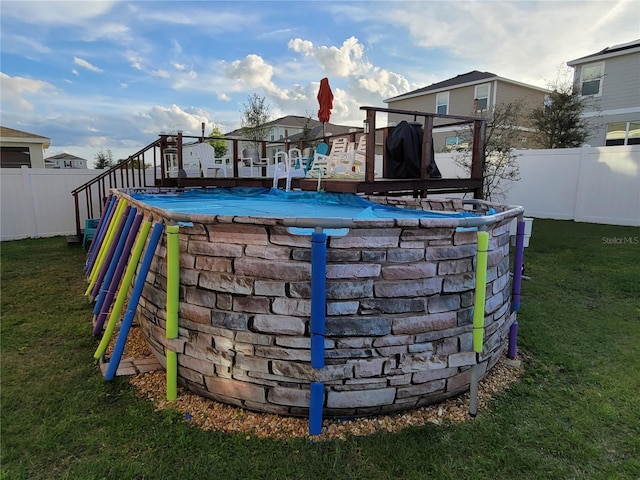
<box><xmin>0</xmin><ymin>219</ymin><xmax>640</xmax><ymax>480</ymax></box>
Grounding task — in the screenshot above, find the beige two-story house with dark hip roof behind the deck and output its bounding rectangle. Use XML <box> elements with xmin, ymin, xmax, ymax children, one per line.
<box><xmin>384</xmin><ymin>70</ymin><xmax>549</xmax><ymax>152</ymax></box>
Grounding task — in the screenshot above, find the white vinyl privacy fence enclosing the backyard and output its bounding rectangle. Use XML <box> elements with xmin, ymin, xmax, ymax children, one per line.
<box><xmin>0</xmin><ymin>145</ymin><xmax>640</xmax><ymax>241</ymax></box>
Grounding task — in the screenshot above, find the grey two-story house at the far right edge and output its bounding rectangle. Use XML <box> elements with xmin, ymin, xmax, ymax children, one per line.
<box><xmin>567</xmin><ymin>40</ymin><xmax>640</xmax><ymax>147</ymax></box>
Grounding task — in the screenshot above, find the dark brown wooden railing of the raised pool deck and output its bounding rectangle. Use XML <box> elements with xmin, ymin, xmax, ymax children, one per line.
<box><xmin>71</xmin><ymin>107</ymin><xmax>486</xmax><ymax>238</ymax></box>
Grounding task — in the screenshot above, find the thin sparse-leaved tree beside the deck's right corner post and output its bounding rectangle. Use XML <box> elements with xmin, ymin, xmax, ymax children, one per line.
<box><xmin>453</xmin><ymin>101</ymin><xmax>525</xmax><ymax>201</ymax></box>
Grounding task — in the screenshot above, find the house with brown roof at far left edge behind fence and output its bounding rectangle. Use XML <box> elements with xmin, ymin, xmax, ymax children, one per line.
<box><xmin>0</xmin><ymin>126</ymin><xmax>51</xmax><ymax>168</ymax></box>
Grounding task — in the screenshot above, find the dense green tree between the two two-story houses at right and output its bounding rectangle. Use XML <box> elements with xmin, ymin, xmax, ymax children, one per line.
<box><xmin>529</xmin><ymin>83</ymin><xmax>590</xmax><ymax>148</ymax></box>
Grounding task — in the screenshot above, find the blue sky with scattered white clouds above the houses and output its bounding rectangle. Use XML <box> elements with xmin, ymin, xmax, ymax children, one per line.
<box><xmin>0</xmin><ymin>0</ymin><xmax>640</xmax><ymax>165</ymax></box>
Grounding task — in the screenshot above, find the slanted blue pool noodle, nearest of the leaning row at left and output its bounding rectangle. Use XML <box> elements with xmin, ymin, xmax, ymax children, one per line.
<box><xmin>104</xmin><ymin>223</ymin><xmax>164</xmax><ymax>381</ymax></box>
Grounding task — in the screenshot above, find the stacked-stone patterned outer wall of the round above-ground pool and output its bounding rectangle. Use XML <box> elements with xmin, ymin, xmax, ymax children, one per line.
<box><xmin>130</xmin><ymin>197</ymin><xmax>515</xmax><ymax>416</ymax></box>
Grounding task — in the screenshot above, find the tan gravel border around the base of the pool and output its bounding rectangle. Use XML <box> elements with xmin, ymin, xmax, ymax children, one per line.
<box><xmin>117</xmin><ymin>328</ymin><xmax>523</xmax><ymax>441</ymax></box>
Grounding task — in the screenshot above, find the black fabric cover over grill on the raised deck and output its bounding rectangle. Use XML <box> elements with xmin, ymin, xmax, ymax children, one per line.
<box><xmin>384</xmin><ymin>120</ymin><xmax>442</xmax><ymax>178</ymax></box>
